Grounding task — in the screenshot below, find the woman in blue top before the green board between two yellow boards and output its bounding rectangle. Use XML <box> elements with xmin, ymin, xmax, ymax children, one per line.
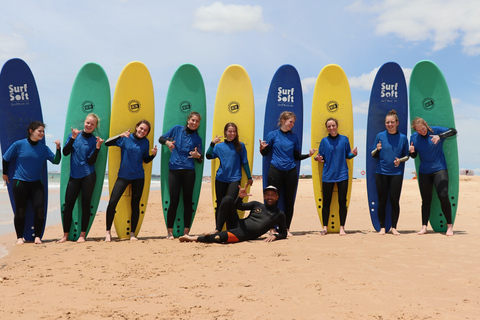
<box><xmin>158</xmin><ymin>111</ymin><xmax>203</xmax><ymax>240</ymax></box>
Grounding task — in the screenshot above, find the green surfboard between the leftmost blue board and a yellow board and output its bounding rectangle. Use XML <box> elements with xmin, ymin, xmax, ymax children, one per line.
<box><xmin>60</xmin><ymin>62</ymin><xmax>111</xmax><ymax>241</ymax></box>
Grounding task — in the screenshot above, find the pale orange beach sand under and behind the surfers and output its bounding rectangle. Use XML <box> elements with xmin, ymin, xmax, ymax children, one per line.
<box><xmin>0</xmin><ymin>176</ymin><xmax>480</xmax><ymax>320</ymax></box>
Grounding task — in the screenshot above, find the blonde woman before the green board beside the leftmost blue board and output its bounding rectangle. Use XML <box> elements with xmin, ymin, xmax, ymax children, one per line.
<box><xmin>58</xmin><ymin>113</ymin><xmax>103</xmax><ymax>243</ymax></box>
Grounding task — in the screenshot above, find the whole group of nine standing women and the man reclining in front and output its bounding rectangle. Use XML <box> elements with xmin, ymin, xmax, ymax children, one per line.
<box><xmin>3</xmin><ymin>110</ymin><xmax>456</xmax><ymax>244</ymax></box>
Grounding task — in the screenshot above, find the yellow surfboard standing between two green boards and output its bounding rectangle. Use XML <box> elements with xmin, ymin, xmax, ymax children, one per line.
<box><xmin>108</xmin><ymin>61</ymin><xmax>155</xmax><ymax>239</ymax></box>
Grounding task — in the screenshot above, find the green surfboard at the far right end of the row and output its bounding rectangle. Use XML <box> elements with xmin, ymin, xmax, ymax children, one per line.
<box><xmin>409</xmin><ymin>60</ymin><xmax>459</xmax><ymax>232</ymax></box>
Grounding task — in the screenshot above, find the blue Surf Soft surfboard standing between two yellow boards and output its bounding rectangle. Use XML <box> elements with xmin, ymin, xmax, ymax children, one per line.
<box><xmin>262</xmin><ymin>64</ymin><xmax>303</xmax><ymax>210</ymax></box>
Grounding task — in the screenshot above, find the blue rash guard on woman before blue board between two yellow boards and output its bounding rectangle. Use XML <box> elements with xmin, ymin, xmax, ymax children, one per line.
<box><xmin>265</xmin><ymin>129</ymin><xmax>302</xmax><ymax>171</ymax></box>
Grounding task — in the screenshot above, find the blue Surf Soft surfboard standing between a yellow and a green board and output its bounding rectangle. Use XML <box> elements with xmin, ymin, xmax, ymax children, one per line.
<box><xmin>365</xmin><ymin>62</ymin><xmax>408</xmax><ymax>232</ymax></box>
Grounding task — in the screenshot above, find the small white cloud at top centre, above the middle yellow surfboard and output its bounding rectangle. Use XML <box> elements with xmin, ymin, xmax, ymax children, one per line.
<box><xmin>193</xmin><ymin>2</ymin><xmax>272</xmax><ymax>34</ymax></box>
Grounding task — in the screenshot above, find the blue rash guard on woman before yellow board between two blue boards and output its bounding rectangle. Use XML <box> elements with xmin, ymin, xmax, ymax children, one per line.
<box><xmin>318</xmin><ymin>134</ymin><xmax>353</xmax><ymax>182</ymax></box>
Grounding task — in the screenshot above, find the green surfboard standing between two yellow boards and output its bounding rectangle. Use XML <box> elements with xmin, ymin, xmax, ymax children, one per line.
<box><xmin>160</xmin><ymin>64</ymin><xmax>207</xmax><ymax>237</ymax></box>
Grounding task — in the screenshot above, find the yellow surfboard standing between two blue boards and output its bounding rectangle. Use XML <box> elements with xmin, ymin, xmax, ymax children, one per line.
<box><xmin>311</xmin><ymin>64</ymin><xmax>353</xmax><ymax>233</ymax></box>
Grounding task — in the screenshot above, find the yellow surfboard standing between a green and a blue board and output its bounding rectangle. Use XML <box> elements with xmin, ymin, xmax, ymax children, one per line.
<box><xmin>211</xmin><ymin>64</ymin><xmax>255</xmax><ymax>218</ymax></box>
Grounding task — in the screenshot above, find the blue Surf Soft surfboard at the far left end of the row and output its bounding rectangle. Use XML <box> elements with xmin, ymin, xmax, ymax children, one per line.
<box><xmin>0</xmin><ymin>59</ymin><xmax>48</xmax><ymax>241</ymax></box>
